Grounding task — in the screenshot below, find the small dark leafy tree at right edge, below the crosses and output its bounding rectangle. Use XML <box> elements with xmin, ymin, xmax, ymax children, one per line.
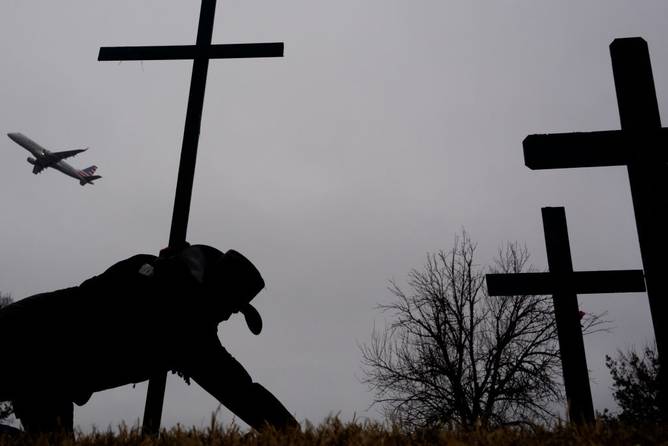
<box><xmin>605</xmin><ymin>345</ymin><xmax>664</xmax><ymax>424</ymax></box>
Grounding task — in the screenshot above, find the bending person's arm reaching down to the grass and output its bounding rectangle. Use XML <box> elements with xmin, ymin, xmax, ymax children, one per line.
<box><xmin>184</xmin><ymin>337</ymin><xmax>299</xmax><ymax>429</ymax></box>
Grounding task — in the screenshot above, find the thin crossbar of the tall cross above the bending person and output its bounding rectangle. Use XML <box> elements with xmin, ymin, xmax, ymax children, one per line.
<box><xmin>97</xmin><ymin>42</ymin><xmax>284</xmax><ymax>61</ymax></box>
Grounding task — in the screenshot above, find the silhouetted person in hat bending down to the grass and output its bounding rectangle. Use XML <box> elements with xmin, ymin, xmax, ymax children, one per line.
<box><xmin>0</xmin><ymin>245</ymin><xmax>298</xmax><ymax>432</ymax></box>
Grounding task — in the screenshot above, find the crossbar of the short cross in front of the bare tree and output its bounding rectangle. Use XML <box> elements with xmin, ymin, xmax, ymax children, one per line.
<box><xmin>487</xmin><ymin>269</ymin><xmax>645</xmax><ymax>296</ymax></box>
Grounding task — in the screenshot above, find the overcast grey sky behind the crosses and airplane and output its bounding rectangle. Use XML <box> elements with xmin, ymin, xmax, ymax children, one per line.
<box><xmin>0</xmin><ymin>0</ymin><xmax>668</xmax><ymax>429</ymax></box>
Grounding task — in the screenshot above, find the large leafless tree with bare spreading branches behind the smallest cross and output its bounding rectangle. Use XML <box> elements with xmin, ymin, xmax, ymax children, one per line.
<box><xmin>361</xmin><ymin>231</ymin><xmax>602</xmax><ymax>428</ymax></box>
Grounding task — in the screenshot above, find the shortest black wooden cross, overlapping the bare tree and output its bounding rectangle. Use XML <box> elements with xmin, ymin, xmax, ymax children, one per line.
<box><xmin>486</xmin><ymin>207</ymin><xmax>645</xmax><ymax>424</ymax></box>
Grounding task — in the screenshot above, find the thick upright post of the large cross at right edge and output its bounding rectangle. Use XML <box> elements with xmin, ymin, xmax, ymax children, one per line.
<box><xmin>610</xmin><ymin>39</ymin><xmax>668</xmax><ymax>416</ymax></box>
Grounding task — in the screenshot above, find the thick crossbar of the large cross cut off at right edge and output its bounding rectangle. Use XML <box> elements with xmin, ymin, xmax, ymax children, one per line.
<box><xmin>522</xmin><ymin>128</ymin><xmax>668</xmax><ymax>170</ymax></box>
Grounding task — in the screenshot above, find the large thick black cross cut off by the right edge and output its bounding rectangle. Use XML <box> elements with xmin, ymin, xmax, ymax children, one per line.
<box><xmin>523</xmin><ymin>37</ymin><xmax>668</xmax><ymax>414</ymax></box>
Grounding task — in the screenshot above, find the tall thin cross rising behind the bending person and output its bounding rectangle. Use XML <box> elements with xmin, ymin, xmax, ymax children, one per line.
<box><xmin>98</xmin><ymin>0</ymin><xmax>283</xmax><ymax>434</ymax></box>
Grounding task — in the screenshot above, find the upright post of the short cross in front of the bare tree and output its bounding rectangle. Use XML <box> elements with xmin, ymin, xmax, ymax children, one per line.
<box><xmin>541</xmin><ymin>207</ymin><xmax>594</xmax><ymax>424</ymax></box>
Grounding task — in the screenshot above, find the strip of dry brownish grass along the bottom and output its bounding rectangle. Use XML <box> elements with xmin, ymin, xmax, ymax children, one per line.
<box><xmin>0</xmin><ymin>419</ymin><xmax>668</xmax><ymax>446</ymax></box>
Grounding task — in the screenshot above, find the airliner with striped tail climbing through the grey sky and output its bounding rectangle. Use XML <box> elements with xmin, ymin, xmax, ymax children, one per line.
<box><xmin>7</xmin><ymin>133</ymin><xmax>102</xmax><ymax>186</ymax></box>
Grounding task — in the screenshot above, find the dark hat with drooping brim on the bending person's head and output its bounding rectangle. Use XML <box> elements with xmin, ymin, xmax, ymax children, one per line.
<box><xmin>179</xmin><ymin>245</ymin><xmax>264</xmax><ymax>335</ymax></box>
